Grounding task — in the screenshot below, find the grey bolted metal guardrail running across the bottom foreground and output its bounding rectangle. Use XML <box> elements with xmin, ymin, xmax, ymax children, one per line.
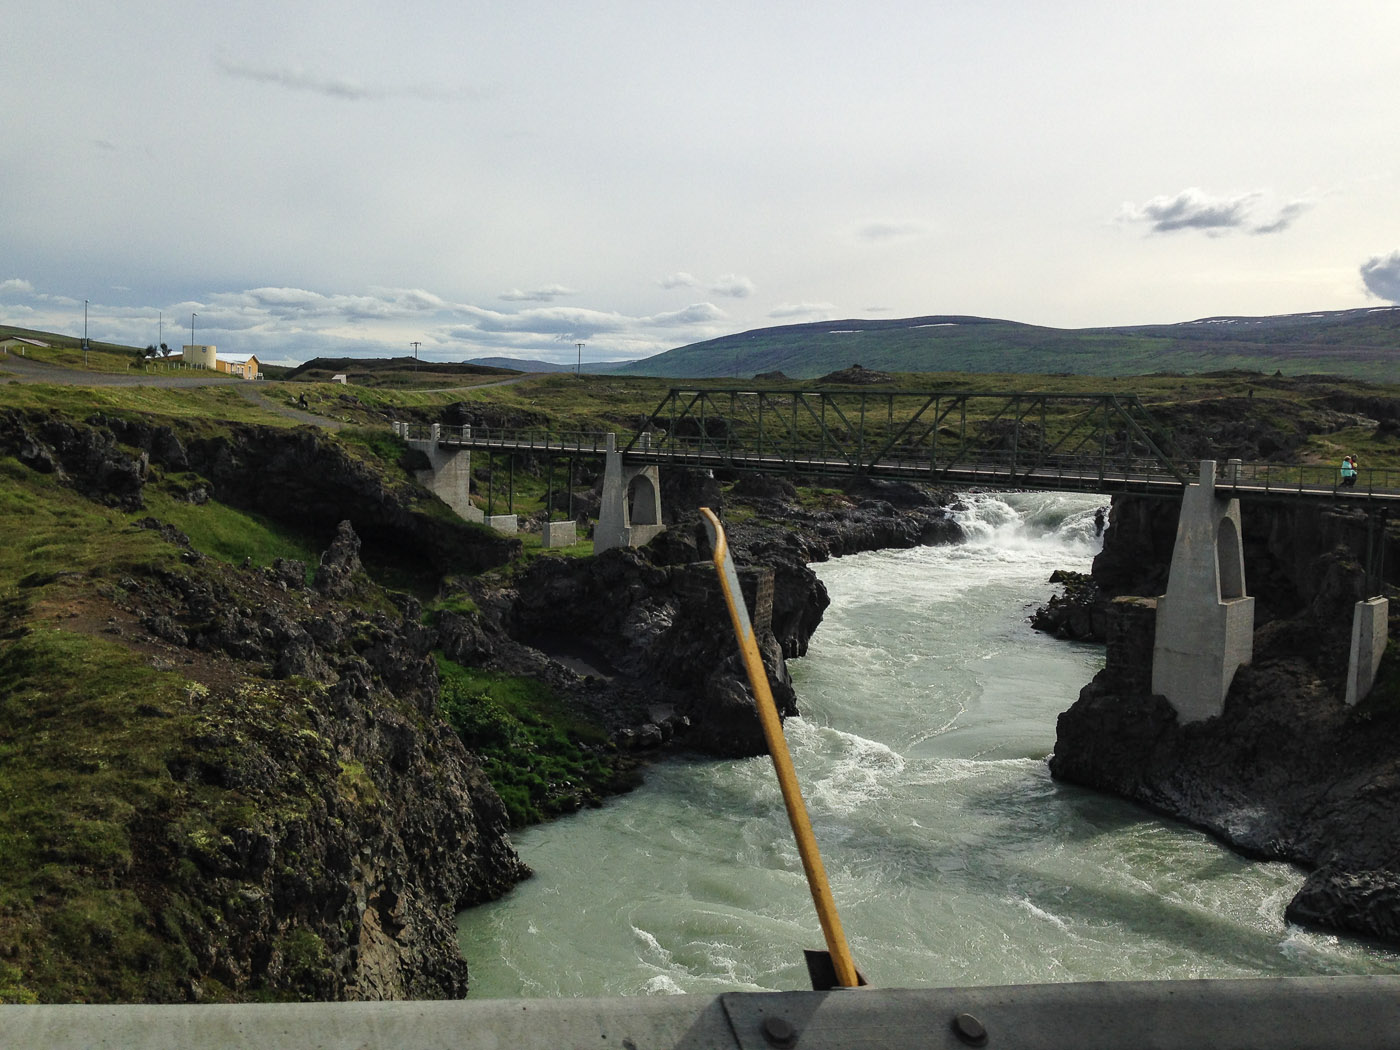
<box><xmin>8</xmin><ymin>976</ymin><xmax>1400</xmax><ymax>1050</ymax></box>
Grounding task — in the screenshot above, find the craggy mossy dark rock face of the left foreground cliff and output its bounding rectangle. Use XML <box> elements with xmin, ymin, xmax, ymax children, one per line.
<box><xmin>120</xmin><ymin>528</ymin><xmax>529</xmax><ymax>1000</ymax></box>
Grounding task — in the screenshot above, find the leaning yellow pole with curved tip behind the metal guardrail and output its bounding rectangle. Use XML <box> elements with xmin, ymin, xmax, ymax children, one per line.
<box><xmin>700</xmin><ymin>507</ymin><xmax>860</xmax><ymax>988</ymax></box>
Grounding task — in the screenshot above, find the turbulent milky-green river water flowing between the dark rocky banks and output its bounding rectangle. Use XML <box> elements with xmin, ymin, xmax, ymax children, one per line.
<box><xmin>459</xmin><ymin>493</ymin><xmax>1400</xmax><ymax>997</ymax></box>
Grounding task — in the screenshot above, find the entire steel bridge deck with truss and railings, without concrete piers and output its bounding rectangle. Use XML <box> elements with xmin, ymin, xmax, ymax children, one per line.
<box><xmin>412</xmin><ymin>388</ymin><xmax>1400</xmax><ymax>508</ymax></box>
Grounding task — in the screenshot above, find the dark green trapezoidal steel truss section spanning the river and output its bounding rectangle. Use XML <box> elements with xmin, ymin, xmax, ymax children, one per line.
<box><xmin>623</xmin><ymin>388</ymin><xmax>1189</xmax><ymax>491</ymax></box>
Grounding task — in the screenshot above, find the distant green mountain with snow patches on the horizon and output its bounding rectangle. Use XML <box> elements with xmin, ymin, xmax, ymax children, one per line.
<box><xmin>610</xmin><ymin>307</ymin><xmax>1400</xmax><ymax>382</ymax></box>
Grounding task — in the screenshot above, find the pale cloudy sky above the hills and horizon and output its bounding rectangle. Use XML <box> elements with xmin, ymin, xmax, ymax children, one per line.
<box><xmin>0</xmin><ymin>0</ymin><xmax>1400</xmax><ymax>364</ymax></box>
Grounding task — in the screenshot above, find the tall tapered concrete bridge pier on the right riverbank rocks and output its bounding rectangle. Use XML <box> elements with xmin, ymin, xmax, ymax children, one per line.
<box><xmin>1152</xmin><ymin>459</ymin><xmax>1254</xmax><ymax>722</ymax></box>
